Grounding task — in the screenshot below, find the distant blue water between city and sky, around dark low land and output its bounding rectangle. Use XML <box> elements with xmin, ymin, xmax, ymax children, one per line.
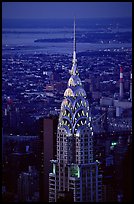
<box><xmin>2</xmin><ymin>18</ymin><xmax>132</xmax><ymax>54</ymax></box>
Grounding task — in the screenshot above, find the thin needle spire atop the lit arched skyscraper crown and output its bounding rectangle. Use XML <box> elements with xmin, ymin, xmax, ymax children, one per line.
<box><xmin>70</xmin><ymin>17</ymin><xmax>77</xmax><ymax>75</ymax></box>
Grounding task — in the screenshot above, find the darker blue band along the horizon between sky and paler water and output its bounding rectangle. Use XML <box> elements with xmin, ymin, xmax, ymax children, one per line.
<box><xmin>2</xmin><ymin>18</ymin><xmax>132</xmax><ymax>28</ymax></box>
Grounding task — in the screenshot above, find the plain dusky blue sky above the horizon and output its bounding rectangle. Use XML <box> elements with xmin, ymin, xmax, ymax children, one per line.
<box><xmin>2</xmin><ymin>2</ymin><xmax>132</xmax><ymax>19</ymax></box>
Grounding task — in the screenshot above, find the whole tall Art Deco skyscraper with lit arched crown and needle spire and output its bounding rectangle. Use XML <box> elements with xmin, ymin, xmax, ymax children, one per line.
<box><xmin>49</xmin><ymin>21</ymin><xmax>102</xmax><ymax>202</ymax></box>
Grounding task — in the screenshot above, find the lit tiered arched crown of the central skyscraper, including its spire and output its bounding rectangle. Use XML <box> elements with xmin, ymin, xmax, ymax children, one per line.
<box><xmin>58</xmin><ymin>17</ymin><xmax>91</xmax><ymax>136</ymax></box>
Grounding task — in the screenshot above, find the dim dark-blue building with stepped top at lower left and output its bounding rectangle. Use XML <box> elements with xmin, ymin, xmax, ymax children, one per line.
<box><xmin>18</xmin><ymin>166</ymin><xmax>39</xmax><ymax>202</ymax></box>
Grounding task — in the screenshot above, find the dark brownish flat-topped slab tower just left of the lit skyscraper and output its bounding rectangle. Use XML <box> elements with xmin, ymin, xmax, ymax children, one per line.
<box><xmin>39</xmin><ymin>116</ymin><xmax>58</xmax><ymax>202</ymax></box>
